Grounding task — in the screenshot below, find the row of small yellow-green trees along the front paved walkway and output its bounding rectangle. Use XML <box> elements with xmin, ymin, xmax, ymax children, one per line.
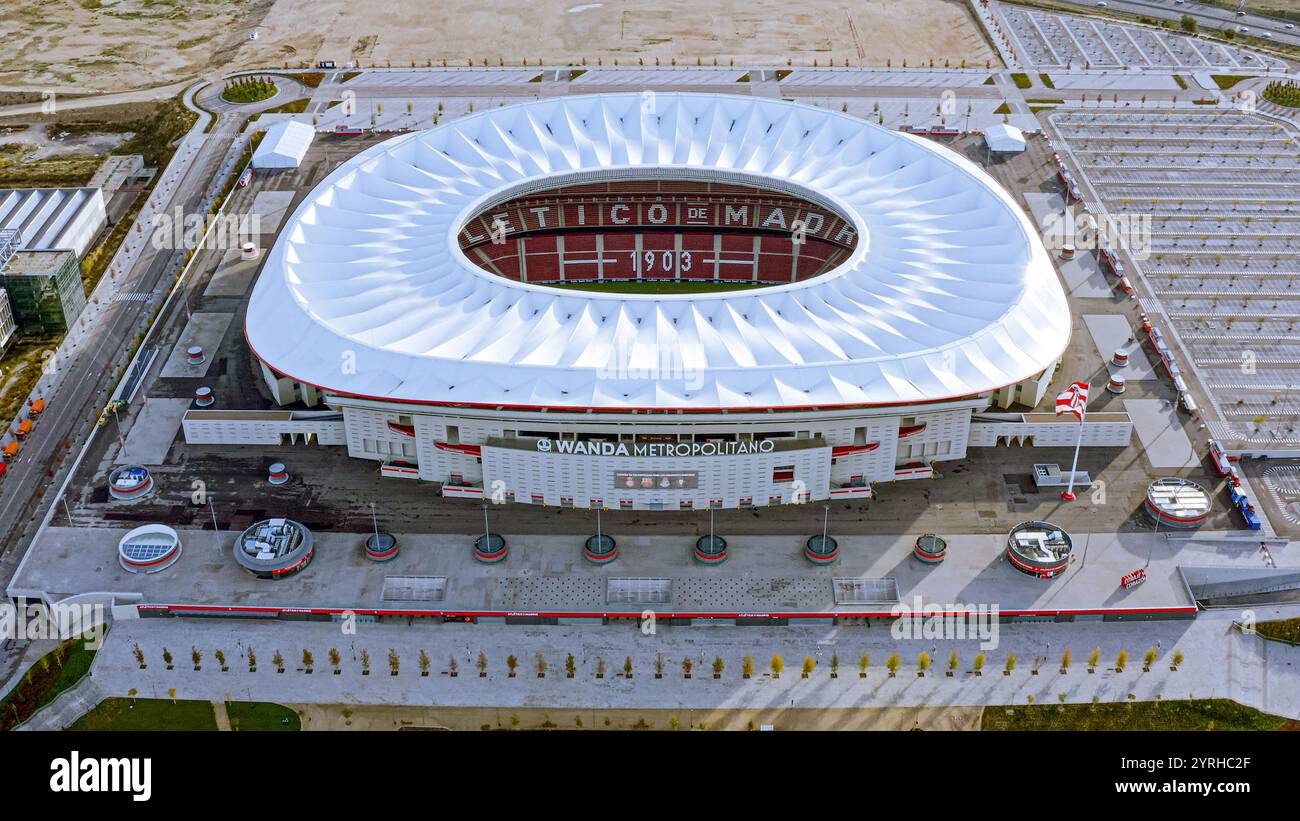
<box><xmin>133</xmin><ymin>644</ymin><xmax>1184</xmax><ymax>678</ymax></box>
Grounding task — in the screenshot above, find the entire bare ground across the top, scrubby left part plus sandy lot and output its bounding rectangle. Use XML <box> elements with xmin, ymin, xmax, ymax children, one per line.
<box><xmin>0</xmin><ymin>0</ymin><xmax>997</xmax><ymax>94</ymax></box>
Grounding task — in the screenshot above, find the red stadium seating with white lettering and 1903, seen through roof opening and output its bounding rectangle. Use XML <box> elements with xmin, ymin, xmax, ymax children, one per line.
<box><xmin>460</xmin><ymin>179</ymin><xmax>853</xmax><ymax>283</ymax></box>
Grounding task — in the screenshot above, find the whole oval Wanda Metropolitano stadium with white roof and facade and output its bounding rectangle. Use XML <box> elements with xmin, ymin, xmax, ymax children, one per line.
<box><xmin>244</xmin><ymin>92</ymin><xmax>1076</xmax><ymax>511</ymax></box>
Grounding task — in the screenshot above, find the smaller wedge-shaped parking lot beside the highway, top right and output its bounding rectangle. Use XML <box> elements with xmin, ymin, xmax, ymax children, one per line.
<box><xmin>995</xmin><ymin>4</ymin><xmax>1286</xmax><ymax>71</ymax></box>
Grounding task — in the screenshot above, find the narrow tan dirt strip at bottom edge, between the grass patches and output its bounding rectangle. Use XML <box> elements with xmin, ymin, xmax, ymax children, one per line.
<box><xmin>297</xmin><ymin>704</ymin><xmax>980</xmax><ymax>731</ymax></box>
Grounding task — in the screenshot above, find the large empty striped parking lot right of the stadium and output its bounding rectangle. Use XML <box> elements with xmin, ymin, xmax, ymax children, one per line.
<box><xmin>1050</xmin><ymin>109</ymin><xmax>1300</xmax><ymax>446</ymax></box>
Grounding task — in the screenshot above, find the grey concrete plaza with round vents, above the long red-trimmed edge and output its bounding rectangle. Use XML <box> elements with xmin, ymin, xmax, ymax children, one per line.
<box><xmin>10</xmin><ymin>527</ymin><xmax>1300</xmax><ymax>617</ymax></box>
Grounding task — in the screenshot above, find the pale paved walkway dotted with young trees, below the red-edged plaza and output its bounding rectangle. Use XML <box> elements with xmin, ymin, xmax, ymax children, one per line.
<box><xmin>53</xmin><ymin>607</ymin><xmax>1300</xmax><ymax>726</ymax></box>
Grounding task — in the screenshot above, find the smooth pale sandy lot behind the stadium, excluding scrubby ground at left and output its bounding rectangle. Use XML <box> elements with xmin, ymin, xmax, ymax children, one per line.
<box><xmin>239</xmin><ymin>0</ymin><xmax>993</xmax><ymax>65</ymax></box>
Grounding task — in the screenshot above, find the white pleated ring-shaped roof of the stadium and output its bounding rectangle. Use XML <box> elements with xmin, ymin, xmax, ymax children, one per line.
<box><xmin>246</xmin><ymin>92</ymin><xmax>1070</xmax><ymax>411</ymax></box>
